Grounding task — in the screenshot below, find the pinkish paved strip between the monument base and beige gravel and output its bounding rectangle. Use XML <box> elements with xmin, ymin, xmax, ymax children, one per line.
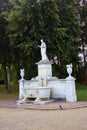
<box><xmin>0</xmin><ymin>99</ymin><xmax>87</xmax><ymax>110</ymax></box>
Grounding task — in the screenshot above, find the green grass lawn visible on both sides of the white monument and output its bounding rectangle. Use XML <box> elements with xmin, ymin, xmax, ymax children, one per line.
<box><xmin>0</xmin><ymin>83</ymin><xmax>87</xmax><ymax>101</ymax></box>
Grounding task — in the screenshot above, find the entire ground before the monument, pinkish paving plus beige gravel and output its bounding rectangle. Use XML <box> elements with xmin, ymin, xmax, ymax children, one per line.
<box><xmin>0</xmin><ymin>99</ymin><xmax>87</xmax><ymax>130</ymax></box>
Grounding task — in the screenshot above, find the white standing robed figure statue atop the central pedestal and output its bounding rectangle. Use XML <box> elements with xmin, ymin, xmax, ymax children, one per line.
<box><xmin>39</xmin><ymin>39</ymin><xmax>48</xmax><ymax>60</ymax></box>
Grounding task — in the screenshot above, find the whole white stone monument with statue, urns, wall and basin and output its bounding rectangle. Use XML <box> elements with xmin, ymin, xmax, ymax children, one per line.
<box><xmin>18</xmin><ymin>40</ymin><xmax>77</xmax><ymax>104</ymax></box>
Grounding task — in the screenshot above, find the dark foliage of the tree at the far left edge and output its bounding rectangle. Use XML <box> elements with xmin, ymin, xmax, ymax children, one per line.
<box><xmin>0</xmin><ymin>0</ymin><xmax>12</xmax><ymax>63</ymax></box>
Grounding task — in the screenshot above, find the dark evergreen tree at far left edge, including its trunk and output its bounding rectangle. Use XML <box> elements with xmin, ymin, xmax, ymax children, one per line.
<box><xmin>0</xmin><ymin>0</ymin><xmax>12</xmax><ymax>92</ymax></box>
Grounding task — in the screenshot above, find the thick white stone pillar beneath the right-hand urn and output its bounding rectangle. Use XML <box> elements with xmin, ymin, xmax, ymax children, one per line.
<box><xmin>66</xmin><ymin>76</ymin><xmax>77</xmax><ymax>102</ymax></box>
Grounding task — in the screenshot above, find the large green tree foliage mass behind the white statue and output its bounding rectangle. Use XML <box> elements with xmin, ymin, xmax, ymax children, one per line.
<box><xmin>2</xmin><ymin>0</ymin><xmax>81</xmax><ymax>77</ymax></box>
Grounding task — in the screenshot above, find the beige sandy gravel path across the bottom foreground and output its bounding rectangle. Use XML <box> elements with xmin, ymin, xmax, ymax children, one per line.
<box><xmin>0</xmin><ymin>107</ymin><xmax>87</xmax><ymax>130</ymax></box>
